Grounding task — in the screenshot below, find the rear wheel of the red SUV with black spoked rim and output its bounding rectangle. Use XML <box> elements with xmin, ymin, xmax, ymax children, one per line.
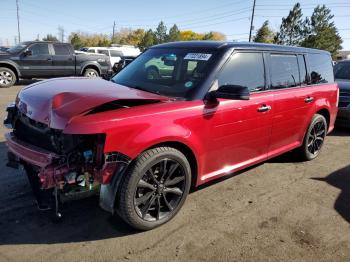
<box><xmin>299</xmin><ymin>114</ymin><xmax>328</xmax><ymax>161</ymax></box>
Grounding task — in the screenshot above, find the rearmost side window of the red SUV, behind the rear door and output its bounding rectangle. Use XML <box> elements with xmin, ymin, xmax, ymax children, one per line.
<box><xmin>308</xmin><ymin>54</ymin><xmax>334</xmax><ymax>84</ymax></box>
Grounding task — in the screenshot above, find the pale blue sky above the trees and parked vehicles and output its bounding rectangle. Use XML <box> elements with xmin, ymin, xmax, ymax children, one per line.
<box><xmin>0</xmin><ymin>0</ymin><xmax>350</xmax><ymax>50</ymax></box>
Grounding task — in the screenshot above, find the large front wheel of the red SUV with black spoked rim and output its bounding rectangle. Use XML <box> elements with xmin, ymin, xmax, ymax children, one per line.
<box><xmin>117</xmin><ymin>147</ymin><xmax>191</xmax><ymax>230</ymax></box>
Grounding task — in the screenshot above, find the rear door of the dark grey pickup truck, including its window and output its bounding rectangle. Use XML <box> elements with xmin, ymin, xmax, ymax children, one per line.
<box><xmin>52</xmin><ymin>43</ymin><xmax>75</xmax><ymax>76</ymax></box>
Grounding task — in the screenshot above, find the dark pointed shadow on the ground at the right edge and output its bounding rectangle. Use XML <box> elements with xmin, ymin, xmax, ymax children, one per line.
<box><xmin>311</xmin><ymin>165</ymin><xmax>350</xmax><ymax>223</ymax></box>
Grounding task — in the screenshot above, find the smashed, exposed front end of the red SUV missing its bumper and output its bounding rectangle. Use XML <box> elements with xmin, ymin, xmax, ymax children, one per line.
<box><xmin>4</xmin><ymin>102</ymin><xmax>131</xmax><ymax>217</ymax></box>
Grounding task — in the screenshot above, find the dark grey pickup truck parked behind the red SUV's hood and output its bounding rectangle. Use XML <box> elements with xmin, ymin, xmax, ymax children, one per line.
<box><xmin>0</xmin><ymin>41</ymin><xmax>112</xmax><ymax>87</ymax></box>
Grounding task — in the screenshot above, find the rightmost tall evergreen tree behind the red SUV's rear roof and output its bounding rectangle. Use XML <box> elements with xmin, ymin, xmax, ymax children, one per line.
<box><xmin>301</xmin><ymin>5</ymin><xmax>342</xmax><ymax>56</ymax></box>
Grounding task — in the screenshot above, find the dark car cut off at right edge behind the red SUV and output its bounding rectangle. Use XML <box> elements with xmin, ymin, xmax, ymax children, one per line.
<box><xmin>334</xmin><ymin>60</ymin><xmax>350</xmax><ymax>128</ymax></box>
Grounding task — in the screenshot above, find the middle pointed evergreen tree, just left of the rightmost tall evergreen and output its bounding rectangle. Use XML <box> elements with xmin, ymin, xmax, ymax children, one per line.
<box><xmin>274</xmin><ymin>3</ymin><xmax>305</xmax><ymax>45</ymax></box>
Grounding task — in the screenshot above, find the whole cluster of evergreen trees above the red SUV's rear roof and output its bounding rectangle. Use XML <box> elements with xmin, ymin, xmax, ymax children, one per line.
<box><xmin>253</xmin><ymin>3</ymin><xmax>343</xmax><ymax>57</ymax></box>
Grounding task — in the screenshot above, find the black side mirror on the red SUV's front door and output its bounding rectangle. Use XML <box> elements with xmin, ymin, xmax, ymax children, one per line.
<box><xmin>209</xmin><ymin>85</ymin><xmax>250</xmax><ymax>100</ymax></box>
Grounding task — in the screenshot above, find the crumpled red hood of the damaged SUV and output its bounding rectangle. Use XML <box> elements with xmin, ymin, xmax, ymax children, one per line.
<box><xmin>16</xmin><ymin>78</ymin><xmax>168</xmax><ymax>130</ymax></box>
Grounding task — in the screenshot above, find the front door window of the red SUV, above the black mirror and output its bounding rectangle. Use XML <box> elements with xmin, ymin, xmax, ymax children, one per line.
<box><xmin>218</xmin><ymin>52</ymin><xmax>265</xmax><ymax>91</ymax></box>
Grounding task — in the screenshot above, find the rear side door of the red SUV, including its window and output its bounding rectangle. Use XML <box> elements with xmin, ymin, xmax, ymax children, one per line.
<box><xmin>269</xmin><ymin>53</ymin><xmax>314</xmax><ymax>157</ymax></box>
